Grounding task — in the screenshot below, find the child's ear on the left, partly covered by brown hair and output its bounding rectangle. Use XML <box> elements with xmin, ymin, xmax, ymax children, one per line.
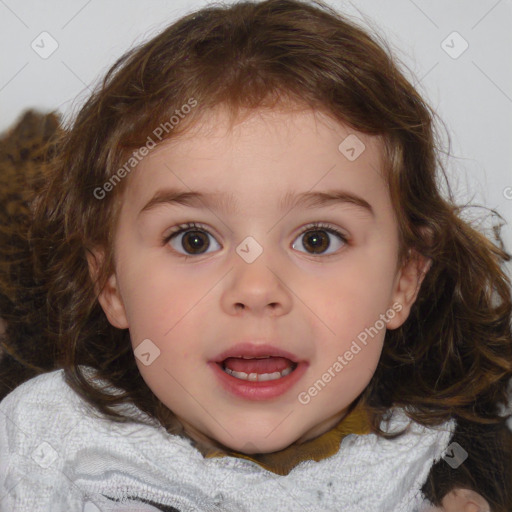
<box><xmin>87</xmin><ymin>249</ymin><xmax>128</xmax><ymax>329</ymax></box>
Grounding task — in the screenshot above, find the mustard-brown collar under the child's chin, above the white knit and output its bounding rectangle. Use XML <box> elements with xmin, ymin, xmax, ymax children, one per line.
<box><xmin>192</xmin><ymin>403</ymin><xmax>371</xmax><ymax>475</ymax></box>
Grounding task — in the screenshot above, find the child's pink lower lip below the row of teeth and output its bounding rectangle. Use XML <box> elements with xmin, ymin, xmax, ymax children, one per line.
<box><xmin>208</xmin><ymin>361</ymin><xmax>308</xmax><ymax>400</ymax></box>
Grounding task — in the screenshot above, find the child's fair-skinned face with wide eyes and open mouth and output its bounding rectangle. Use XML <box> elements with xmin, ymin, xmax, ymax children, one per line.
<box><xmin>95</xmin><ymin>105</ymin><xmax>428</xmax><ymax>453</ymax></box>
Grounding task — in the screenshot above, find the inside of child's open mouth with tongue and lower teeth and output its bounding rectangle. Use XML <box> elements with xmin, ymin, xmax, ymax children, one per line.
<box><xmin>217</xmin><ymin>356</ymin><xmax>297</xmax><ymax>382</ymax></box>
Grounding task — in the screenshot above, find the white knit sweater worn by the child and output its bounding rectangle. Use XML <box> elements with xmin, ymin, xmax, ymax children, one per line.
<box><xmin>0</xmin><ymin>370</ymin><xmax>455</xmax><ymax>512</ymax></box>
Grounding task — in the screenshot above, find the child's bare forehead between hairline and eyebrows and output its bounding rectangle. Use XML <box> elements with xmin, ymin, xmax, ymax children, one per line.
<box><xmin>120</xmin><ymin>109</ymin><xmax>386</xmax><ymax>219</ymax></box>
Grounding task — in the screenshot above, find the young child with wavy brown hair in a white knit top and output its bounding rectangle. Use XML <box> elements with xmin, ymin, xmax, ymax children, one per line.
<box><xmin>0</xmin><ymin>0</ymin><xmax>512</xmax><ymax>512</ymax></box>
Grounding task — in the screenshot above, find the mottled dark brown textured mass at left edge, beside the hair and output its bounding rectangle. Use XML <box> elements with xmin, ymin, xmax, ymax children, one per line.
<box><xmin>0</xmin><ymin>110</ymin><xmax>60</xmax><ymax>398</ymax></box>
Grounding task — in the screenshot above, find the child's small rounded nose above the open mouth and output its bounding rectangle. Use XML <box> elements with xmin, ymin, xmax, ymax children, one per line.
<box><xmin>221</xmin><ymin>247</ymin><xmax>293</xmax><ymax>316</ymax></box>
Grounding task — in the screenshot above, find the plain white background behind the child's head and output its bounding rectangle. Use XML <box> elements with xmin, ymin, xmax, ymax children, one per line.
<box><xmin>0</xmin><ymin>0</ymin><xmax>512</xmax><ymax>269</ymax></box>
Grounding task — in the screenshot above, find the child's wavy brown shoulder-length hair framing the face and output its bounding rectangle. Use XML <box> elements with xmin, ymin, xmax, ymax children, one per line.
<box><xmin>1</xmin><ymin>0</ymin><xmax>512</xmax><ymax>511</ymax></box>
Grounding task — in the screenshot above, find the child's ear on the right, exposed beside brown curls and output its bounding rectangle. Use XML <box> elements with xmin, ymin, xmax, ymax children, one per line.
<box><xmin>386</xmin><ymin>249</ymin><xmax>432</xmax><ymax>329</ymax></box>
